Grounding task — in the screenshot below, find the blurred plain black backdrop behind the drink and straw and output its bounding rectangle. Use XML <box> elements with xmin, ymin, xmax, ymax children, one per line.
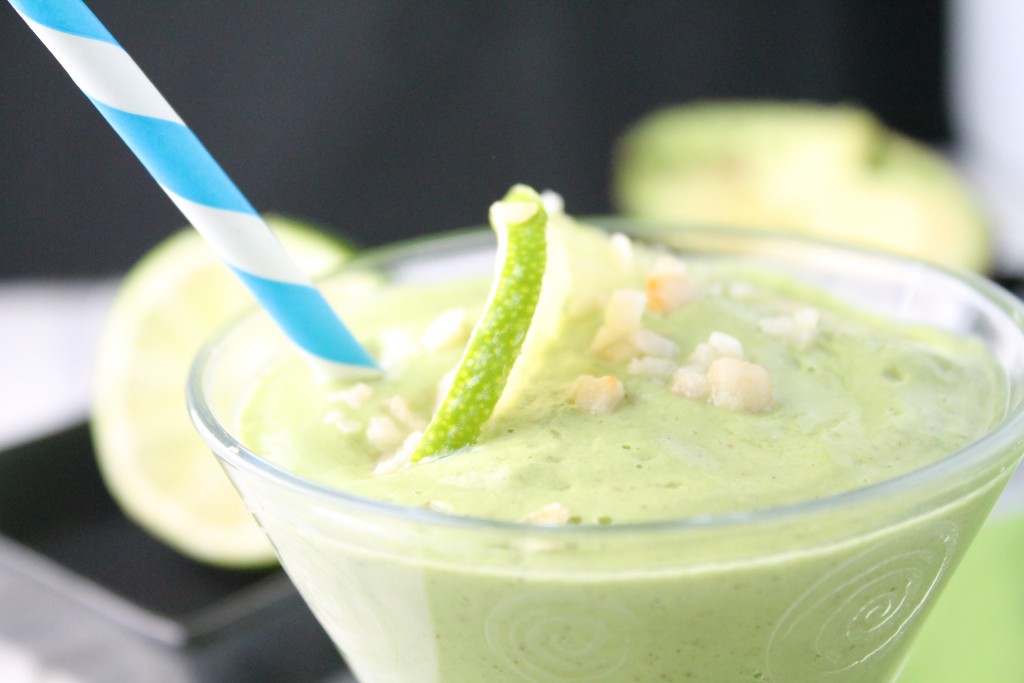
<box><xmin>0</xmin><ymin>0</ymin><xmax>950</xmax><ymax>278</ymax></box>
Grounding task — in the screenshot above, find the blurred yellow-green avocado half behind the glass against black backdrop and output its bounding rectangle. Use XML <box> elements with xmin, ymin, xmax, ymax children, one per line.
<box><xmin>612</xmin><ymin>100</ymin><xmax>992</xmax><ymax>272</ymax></box>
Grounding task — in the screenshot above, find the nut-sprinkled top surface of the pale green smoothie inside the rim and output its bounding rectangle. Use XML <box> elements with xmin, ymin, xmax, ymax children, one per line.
<box><xmin>238</xmin><ymin>218</ymin><xmax>1007</xmax><ymax>524</ymax></box>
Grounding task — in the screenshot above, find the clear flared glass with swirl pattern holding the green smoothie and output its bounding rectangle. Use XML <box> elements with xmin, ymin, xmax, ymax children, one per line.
<box><xmin>188</xmin><ymin>221</ymin><xmax>1024</xmax><ymax>683</ymax></box>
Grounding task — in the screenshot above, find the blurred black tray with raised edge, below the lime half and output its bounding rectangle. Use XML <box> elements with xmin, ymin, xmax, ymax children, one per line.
<box><xmin>0</xmin><ymin>425</ymin><xmax>351</xmax><ymax>683</ymax></box>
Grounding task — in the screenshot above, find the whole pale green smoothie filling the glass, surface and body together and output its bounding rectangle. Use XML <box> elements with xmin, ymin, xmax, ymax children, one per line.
<box><xmin>193</xmin><ymin>208</ymin><xmax>1024</xmax><ymax>683</ymax></box>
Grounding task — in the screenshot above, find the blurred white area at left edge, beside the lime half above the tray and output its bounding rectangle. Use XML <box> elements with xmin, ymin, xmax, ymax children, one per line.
<box><xmin>0</xmin><ymin>281</ymin><xmax>116</xmax><ymax>448</ymax></box>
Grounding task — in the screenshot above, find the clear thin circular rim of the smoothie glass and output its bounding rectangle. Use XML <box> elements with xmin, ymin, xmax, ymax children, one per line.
<box><xmin>186</xmin><ymin>224</ymin><xmax>1024</xmax><ymax>538</ymax></box>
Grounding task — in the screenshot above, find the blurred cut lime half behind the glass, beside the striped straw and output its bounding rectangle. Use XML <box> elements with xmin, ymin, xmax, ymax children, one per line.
<box><xmin>91</xmin><ymin>216</ymin><xmax>351</xmax><ymax>567</ymax></box>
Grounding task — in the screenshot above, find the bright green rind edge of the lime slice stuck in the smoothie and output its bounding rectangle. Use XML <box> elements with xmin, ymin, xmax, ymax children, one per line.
<box><xmin>411</xmin><ymin>185</ymin><xmax>548</xmax><ymax>462</ymax></box>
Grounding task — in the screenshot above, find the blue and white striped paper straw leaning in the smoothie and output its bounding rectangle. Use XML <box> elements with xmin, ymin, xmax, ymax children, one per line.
<box><xmin>9</xmin><ymin>0</ymin><xmax>376</xmax><ymax>374</ymax></box>
